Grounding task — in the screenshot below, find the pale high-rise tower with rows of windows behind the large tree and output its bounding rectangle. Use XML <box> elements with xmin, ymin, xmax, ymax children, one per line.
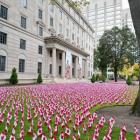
<box><xmin>83</xmin><ymin>0</ymin><xmax>122</xmax><ymax>48</ymax></box>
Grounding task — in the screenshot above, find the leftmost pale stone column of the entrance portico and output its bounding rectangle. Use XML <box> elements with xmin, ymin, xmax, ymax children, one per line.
<box><xmin>52</xmin><ymin>48</ymin><xmax>56</xmax><ymax>78</ymax></box>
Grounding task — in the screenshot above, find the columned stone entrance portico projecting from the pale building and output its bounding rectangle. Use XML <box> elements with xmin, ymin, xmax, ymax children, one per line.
<box><xmin>45</xmin><ymin>37</ymin><xmax>88</xmax><ymax>79</ymax></box>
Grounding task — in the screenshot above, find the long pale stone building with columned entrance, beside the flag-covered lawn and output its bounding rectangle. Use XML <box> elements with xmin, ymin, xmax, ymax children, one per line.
<box><xmin>0</xmin><ymin>0</ymin><xmax>94</xmax><ymax>83</ymax></box>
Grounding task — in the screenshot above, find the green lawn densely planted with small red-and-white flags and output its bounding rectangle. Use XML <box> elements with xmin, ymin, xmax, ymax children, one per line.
<box><xmin>0</xmin><ymin>83</ymin><xmax>136</xmax><ymax>140</ymax></box>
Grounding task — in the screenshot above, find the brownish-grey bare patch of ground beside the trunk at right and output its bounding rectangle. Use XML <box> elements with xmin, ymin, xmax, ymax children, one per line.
<box><xmin>97</xmin><ymin>106</ymin><xmax>140</xmax><ymax>132</ymax></box>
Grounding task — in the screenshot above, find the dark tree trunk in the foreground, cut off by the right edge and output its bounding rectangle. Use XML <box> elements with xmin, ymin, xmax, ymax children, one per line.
<box><xmin>128</xmin><ymin>0</ymin><xmax>140</xmax><ymax>116</ymax></box>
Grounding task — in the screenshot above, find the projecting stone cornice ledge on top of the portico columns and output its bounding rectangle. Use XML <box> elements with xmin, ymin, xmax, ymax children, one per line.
<box><xmin>45</xmin><ymin>36</ymin><xmax>89</xmax><ymax>57</ymax></box>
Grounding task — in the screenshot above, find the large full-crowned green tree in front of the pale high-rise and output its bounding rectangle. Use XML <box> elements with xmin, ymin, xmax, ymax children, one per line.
<box><xmin>95</xmin><ymin>26</ymin><xmax>137</xmax><ymax>82</ymax></box>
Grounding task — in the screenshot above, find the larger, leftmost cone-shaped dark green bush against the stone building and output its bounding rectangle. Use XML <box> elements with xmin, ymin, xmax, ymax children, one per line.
<box><xmin>9</xmin><ymin>68</ymin><xmax>18</xmax><ymax>85</ymax></box>
